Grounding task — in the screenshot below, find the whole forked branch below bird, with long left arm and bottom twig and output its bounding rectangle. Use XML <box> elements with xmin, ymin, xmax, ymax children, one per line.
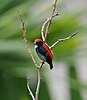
<box><xmin>17</xmin><ymin>9</ymin><xmax>44</xmax><ymax>100</ymax></box>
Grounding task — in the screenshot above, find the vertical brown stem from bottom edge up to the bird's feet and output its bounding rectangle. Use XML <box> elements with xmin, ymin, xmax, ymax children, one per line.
<box><xmin>35</xmin><ymin>62</ymin><xmax>44</xmax><ymax>100</ymax></box>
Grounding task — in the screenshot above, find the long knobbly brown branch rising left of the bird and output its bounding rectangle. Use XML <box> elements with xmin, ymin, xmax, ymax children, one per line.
<box><xmin>17</xmin><ymin>9</ymin><xmax>38</xmax><ymax>68</ymax></box>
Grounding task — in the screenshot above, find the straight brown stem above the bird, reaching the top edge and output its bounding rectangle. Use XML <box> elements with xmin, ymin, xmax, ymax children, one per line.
<box><xmin>45</xmin><ymin>0</ymin><xmax>57</xmax><ymax>41</ymax></box>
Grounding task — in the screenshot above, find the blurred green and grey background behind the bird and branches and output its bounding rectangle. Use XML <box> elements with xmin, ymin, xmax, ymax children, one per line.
<box><xmin>0</xmin><ymin>0</ymin><xmax>87</xmax><ymax>100</ymax></box>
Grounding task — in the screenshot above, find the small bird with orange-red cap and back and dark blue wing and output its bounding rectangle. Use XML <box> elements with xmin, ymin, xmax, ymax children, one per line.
<box><xmin>34</xmin><ymin>39</ymin><xmax>53</xmax><ymax>69</ymax></box>
